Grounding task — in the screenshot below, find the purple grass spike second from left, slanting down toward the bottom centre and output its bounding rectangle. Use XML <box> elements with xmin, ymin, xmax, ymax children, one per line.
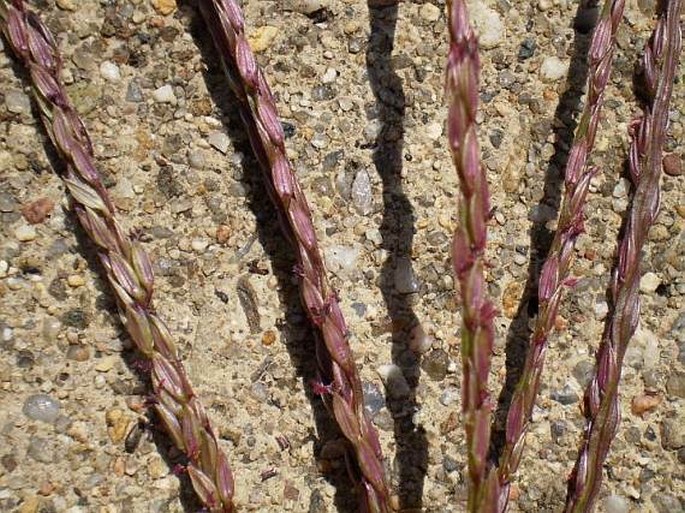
<box><xmin>200</xmin><ymin>0</ymin><xmax>391</xmax><ymax>513</ymax></box>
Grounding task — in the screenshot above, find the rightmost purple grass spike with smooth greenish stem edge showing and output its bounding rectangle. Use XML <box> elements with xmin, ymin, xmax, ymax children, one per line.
<box><xmin>566</xmin><ymin>0</ymin><xmax>683</xmax><ymax>513</ymax></box>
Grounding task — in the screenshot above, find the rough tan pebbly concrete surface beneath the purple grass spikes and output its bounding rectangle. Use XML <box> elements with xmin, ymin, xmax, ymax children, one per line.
<box><xmin>0</xmin><ymin>0</ymin><xmax>685</xmax><ymax>513</ymax></box>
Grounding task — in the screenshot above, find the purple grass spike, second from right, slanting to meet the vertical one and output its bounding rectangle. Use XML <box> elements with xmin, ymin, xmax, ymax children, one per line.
<box><xmin>497</xmin><ymin>0</ymin><xmax>625</xmax><ymax>511</ymax></box>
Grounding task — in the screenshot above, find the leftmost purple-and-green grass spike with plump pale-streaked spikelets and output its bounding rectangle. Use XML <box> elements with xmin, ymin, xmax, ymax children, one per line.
<box><xmin>0</xmin><ymin>0</ymin><xmax>234</xmax><ymax>513</ymax></box>
